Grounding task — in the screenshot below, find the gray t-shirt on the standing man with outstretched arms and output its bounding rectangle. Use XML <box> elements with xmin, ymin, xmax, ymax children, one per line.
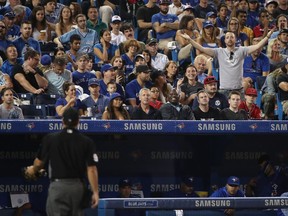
<box><xmin>214</xmin><ymin>46</ymin><xmax>248</xmax><ymax>90</ymax></box>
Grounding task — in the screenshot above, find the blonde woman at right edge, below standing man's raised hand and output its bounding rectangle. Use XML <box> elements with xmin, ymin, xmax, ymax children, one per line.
<box><xmin>267</xmin><ymin>38</ymin><xmax>288</xmax><ymax>71</ymax></box>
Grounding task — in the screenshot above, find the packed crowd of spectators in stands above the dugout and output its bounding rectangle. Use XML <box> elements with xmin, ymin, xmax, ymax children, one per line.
<box><xmin>0</xmin><ymin>0</ymin><xmax>288</xmax><ymax>120</ymax></box>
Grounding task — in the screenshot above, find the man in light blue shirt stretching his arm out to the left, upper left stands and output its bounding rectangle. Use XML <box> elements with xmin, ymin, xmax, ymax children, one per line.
<box><xmin>54</xmin><ymin>14</ymin><xmax>99</xmax><ymax>53</ymax></box>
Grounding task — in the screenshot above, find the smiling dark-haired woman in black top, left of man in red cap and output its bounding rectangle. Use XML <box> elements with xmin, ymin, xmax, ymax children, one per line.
<box><xmin>177</xmin><ymin>64</ymin><xmax>203</xmax><ymax>105</ymax></box>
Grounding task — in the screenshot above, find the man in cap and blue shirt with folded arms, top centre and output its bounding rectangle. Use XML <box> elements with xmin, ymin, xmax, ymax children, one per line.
<box><xmin>152</xmin><ymin>0</ymin><xmax>179</xmax><ymax>54</ymax></box>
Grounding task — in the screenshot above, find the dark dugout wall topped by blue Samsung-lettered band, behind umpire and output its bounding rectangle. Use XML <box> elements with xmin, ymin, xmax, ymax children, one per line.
<box><xmin>0</xmin><ymin>121</ymin><xmax>288</xmax><ymax>212</ymax></box>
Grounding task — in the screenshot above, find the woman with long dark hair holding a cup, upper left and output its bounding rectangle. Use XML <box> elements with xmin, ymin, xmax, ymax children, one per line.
<box><xmin>30</xmin><ymin>6</ymin><xmax>53</xmax><ymax>42</ymax></box>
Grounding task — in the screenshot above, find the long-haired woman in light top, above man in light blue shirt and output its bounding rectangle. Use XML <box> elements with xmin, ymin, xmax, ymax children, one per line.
<box><xmin>55</xmin><ymin>6</ymin><xmax>73</xmax><ymax>37</ymax></box>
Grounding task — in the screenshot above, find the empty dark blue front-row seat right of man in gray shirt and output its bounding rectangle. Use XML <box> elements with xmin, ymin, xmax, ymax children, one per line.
<box><xmin>19</xmin><ymin>104</ymin><xmax>46</xmax><ymax>119</ymax></box>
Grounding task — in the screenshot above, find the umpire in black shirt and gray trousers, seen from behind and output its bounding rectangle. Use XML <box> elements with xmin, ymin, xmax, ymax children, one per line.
<box><xmin>25</xmin><ymin>108</ymin><xmax>99</xmax><ymax>216</ymax></box>
